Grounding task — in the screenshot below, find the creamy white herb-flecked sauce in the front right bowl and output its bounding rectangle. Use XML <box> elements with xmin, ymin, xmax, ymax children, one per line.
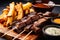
<box><xmin>45</xmin><ymin>27</ymin><xmax>60</xmax><ymax>36</ymax></box>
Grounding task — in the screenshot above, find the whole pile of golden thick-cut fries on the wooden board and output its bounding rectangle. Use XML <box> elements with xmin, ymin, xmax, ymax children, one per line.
<box><xmin>0</xmin><ymin>2</ymin><xmax>34</xmax><ymax>26</ymax></box>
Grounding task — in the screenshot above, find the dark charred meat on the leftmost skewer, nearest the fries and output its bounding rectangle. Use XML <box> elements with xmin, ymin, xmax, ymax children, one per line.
<box><xmin>15</xmin><ymin>14</ymin><xmax>40</xmax><ymax>30</ymax></box>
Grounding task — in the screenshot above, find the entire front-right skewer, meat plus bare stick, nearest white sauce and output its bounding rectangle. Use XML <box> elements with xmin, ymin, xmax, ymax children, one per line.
<box><xmin>21</xmin><ymin>18</ymin><xmax>49</xmax><ymax>40</ymax></box>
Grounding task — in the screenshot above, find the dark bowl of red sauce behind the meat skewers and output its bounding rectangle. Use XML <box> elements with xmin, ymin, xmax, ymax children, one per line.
<box><xmin>33</xmin><ymin>3</ymin><xmax>53</xmax><ymax>12</ymax></box>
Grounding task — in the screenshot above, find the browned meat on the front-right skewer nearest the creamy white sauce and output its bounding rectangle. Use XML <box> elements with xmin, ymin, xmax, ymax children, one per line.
<box><xmin>31</xmin><ymin>17</ymin><xmax>49</xmax><ymax>33</ymax></box>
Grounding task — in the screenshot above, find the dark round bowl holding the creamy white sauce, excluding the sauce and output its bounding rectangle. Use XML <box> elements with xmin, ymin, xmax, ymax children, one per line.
<box><xmin>42</xmin><ymin>25</ymin><xmax>60</xmax><ymax>40</ymax></box>
